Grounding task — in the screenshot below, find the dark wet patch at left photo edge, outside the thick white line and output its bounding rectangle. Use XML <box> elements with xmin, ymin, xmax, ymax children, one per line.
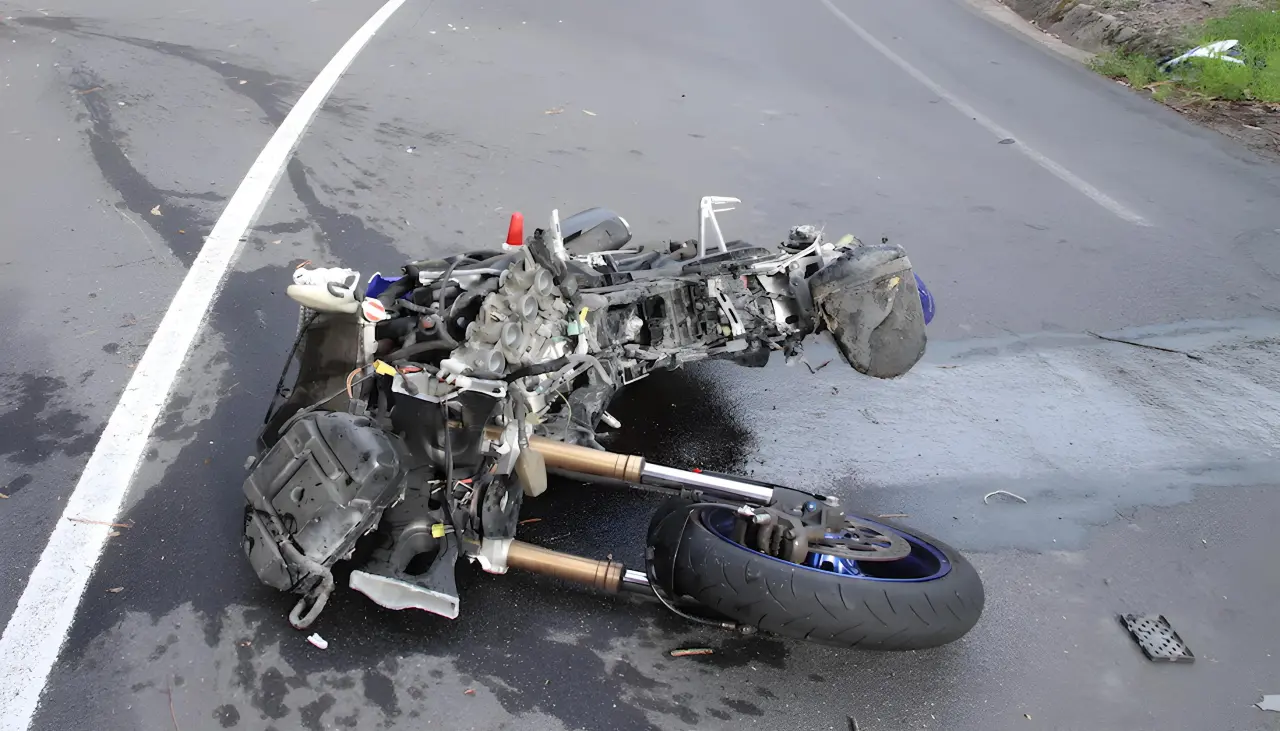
<box><xmin>0</xmin><ymin>373</ymin><xmax>101</xmax><ymax>465</ymax></box>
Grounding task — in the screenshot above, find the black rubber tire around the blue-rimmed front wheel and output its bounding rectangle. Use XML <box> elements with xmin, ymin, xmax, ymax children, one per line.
<box><xmin>650</xmin><ymin>504</ymin><xmax>984</xmax><ymax>650</ymax></box>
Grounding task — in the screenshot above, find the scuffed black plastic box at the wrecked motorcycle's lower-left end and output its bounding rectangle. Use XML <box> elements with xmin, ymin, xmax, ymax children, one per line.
<box><xmin>243</xmin><ymin>412</ymin><xmax>408</xmax><ymax>591</ymax></box>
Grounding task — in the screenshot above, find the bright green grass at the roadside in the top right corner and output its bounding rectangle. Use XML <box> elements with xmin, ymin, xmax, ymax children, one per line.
<box><xmin>1093</xmin><ymin>0</ymin><xmax>1280</xmax><ymax>102</ymax></box>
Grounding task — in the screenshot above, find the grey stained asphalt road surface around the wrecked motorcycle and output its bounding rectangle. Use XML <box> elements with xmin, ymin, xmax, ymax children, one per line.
<box><xmin>0</xmin><ymin>0</ymin><xmax>1280</xmax><ymax>731</ymax></box>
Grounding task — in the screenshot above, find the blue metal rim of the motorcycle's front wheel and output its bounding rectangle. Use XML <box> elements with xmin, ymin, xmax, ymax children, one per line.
<box><xmin>701</xmin><ymin>507</ymin><xmax>951</xmax><ymax>582</ymax></box>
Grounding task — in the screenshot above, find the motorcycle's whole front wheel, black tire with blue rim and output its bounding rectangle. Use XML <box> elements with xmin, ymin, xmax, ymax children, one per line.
<box><xmin>649</xmin><ymin>503</ymin><xmax>984</xmax><ymax>650</ymax></box>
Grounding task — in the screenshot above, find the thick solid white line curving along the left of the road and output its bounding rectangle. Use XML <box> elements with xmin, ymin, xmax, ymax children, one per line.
<box><xmin>0</xmin><ymin>0</ymin><xmax>404</xmax><ymax>731</ymax></box>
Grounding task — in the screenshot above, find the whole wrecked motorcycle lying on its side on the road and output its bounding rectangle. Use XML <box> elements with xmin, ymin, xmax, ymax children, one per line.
<box><xmin>243</xmin><ymin>197</ymin><xmax>983</xmax><ymax>650</ymax></box>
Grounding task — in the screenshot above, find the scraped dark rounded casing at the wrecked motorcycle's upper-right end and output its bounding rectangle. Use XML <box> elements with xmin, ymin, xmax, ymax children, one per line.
<box><xmin>809</xmin><ymin>243</ymin><xmax>925</xmax><ymax>378</ymax></box>
